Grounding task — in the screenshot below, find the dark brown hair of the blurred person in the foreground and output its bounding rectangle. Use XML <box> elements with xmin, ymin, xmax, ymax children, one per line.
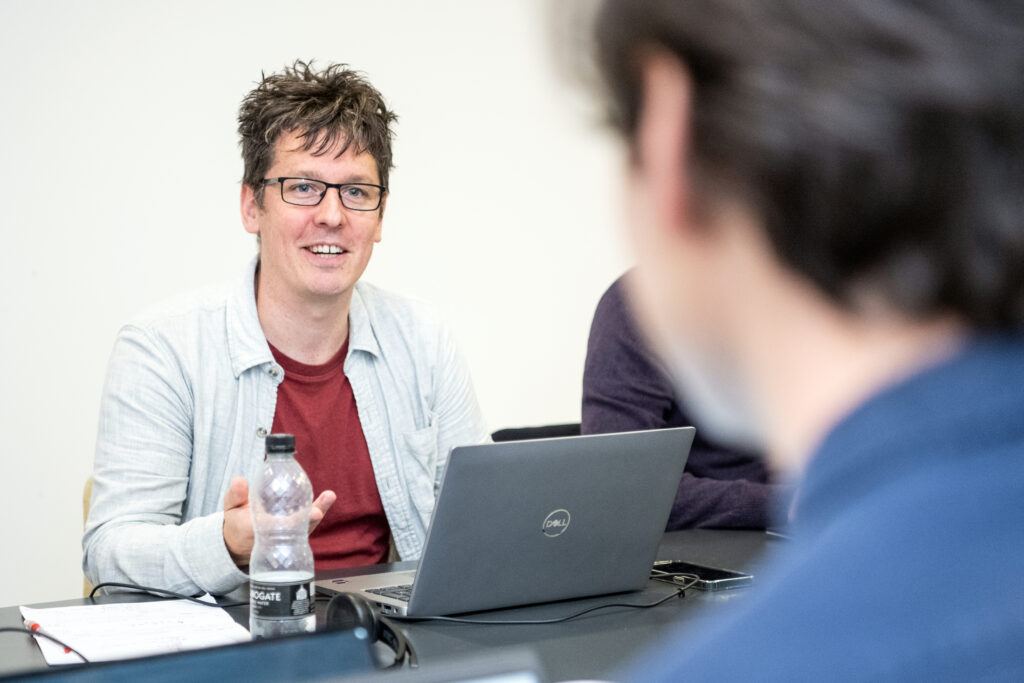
<box><xmin>596</xmin><ymin>0</ymin><xmax>1024</xmax><ymax>330</ymax></box>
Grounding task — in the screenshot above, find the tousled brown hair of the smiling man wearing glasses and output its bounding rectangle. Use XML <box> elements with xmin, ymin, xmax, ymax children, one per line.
<box><xmin>239</xmin><ymin>60</ymin><xmax>398</xmax><ymax>205</ymax></box>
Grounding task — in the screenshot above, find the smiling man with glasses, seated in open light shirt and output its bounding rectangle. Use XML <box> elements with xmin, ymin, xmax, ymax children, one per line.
<box><xmin>83</xmin><ymin>61</ymin><xmax>486</xmax><ymax>594</ymax></box>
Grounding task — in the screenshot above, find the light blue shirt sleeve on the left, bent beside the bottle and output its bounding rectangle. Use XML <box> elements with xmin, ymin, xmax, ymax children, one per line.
<box><xmin>82</xmin><ymin>326</ymin><xmax>247</xmax><ymax>594</ymax></box>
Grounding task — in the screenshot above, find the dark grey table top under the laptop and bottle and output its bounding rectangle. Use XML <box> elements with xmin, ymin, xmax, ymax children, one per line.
<box><xmin>0</xmin><ymin>529</ymin><xmax>770</xmax><ymax>681</ymax></box>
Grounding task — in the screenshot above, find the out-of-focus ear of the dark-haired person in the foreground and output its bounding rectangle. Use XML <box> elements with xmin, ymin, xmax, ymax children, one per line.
<box><xmin>635</xmin><ymin>51</ymin><xmax>692</xmax><ymax>235</ymax></box>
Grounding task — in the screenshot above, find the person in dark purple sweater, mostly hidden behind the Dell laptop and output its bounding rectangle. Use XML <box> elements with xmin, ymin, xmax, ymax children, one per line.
<box><xmin>580</xmin><ymin>273</ymin><xmax>781</xmax><ymax>530</ymax></box>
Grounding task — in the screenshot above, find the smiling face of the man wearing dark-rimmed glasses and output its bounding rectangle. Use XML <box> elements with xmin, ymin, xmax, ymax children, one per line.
<box><xmin>242</xmin><ymin>132</ymin><xmax>386</xmax><ymax>302</ymax></box>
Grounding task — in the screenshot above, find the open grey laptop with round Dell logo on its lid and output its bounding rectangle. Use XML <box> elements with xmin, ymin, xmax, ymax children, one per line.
<box><xmin>316</xmin><ymin>427</ymin><xmax>695</xmax><ymax>616</ymax></box>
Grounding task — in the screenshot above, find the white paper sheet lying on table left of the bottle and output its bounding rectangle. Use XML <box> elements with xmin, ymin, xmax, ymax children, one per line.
<box><xmin>20</xmin><ymin>596</ymin><xmax>250</xmax><ymax>666</ymax></box>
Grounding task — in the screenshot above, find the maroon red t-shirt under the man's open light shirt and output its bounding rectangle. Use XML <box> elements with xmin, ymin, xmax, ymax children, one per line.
<box><xmin>270</xmin><ymin>340</ymin><xmax>390</xmax><ymax>569</ymax></box>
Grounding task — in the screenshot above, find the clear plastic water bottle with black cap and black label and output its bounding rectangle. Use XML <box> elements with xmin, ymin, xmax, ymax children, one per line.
<box><xmin>249</xmin><ymin>434</ymin><xmax>316</xmax><ymax>639</ymax></box>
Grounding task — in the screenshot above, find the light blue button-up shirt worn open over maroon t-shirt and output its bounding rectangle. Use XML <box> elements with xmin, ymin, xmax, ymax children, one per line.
<box><xmin>82</xmin><ymin>260</ymin><xmax>487</xmax><ymax>594</ymax></box>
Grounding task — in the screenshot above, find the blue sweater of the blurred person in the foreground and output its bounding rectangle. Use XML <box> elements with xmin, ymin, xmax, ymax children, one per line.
<box><xmin>623</xmin><ymin>338</ymin><xmax>1024</xmax><ymax>681</ymax></box>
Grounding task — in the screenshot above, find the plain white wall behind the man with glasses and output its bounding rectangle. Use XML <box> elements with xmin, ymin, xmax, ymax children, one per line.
<box><xmin>0</xmin><ymin>0</ymin><xmax>629</xmax><ymax>605</ymax></box>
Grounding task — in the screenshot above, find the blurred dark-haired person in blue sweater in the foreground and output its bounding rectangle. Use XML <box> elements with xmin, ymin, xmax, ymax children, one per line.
<box><xmin>597</xmin><ymin>0</ymin><xmax>1024</xmax><ymax>681</ymax></box>
